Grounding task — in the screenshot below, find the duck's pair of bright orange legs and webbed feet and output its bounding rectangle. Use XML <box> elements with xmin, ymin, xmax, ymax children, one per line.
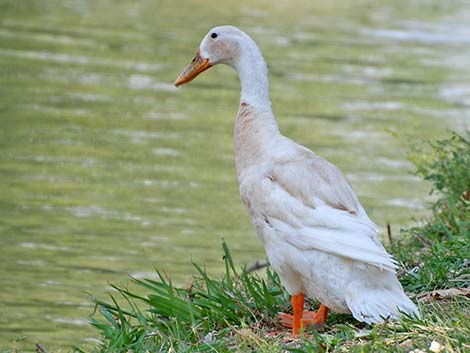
<box><xmin>279</xmin><ymin>293</ymin><xmax>329</xmax><ymax>336</ymax></box>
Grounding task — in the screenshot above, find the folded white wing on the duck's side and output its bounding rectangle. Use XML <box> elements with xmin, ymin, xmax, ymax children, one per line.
<box><xmin>260</xmin><ymin>144</ymin><xmax>397</xmax><ymax>272</ymax></box>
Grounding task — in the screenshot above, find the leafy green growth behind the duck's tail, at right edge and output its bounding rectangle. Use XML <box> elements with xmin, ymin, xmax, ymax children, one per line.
<box><xmin>392</xmin><ymin>134</ymin><xmax>470</xmax><ymax>291</ymax></box>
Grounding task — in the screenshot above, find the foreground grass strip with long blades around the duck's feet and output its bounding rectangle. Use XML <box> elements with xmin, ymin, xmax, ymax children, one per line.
<box><xmin>83</xmin><ymin>250</ymin><xmax>470</xmax><ymax>352</ymax></box>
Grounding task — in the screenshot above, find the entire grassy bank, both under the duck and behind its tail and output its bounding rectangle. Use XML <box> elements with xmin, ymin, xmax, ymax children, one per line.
<box><xmin>71</xmin><ymin>134</ymin><xmax>470</xmax><ymax>353</ymax></box>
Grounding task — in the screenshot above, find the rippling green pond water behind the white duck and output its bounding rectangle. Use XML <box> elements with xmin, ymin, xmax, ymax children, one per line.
<box><xmin>0</xmin><ymin>0</ymin><xmax>470</xmax><ymax>351</ymax></box>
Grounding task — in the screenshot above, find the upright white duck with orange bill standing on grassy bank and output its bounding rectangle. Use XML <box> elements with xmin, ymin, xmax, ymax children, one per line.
<box><xmin>175</xmin><ymin>26</ymin><xmax>419</xmax><ymax>335</ymax></box>
